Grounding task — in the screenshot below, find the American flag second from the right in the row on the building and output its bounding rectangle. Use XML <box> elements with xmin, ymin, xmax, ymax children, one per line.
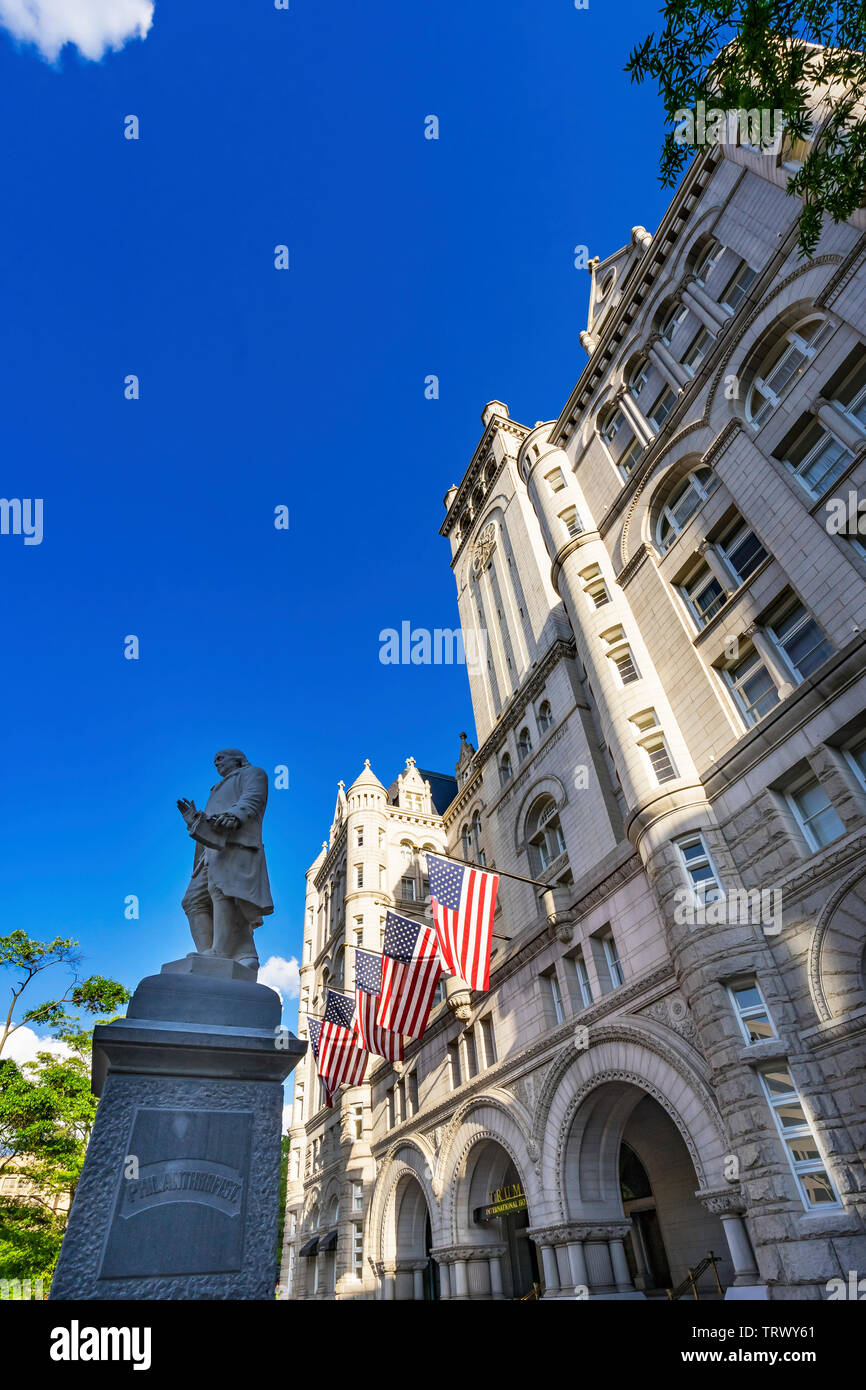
<box><xmin>375</xmin><ymin>912</ymin><xmax>442</xmax><ymax>1038</ymax></box>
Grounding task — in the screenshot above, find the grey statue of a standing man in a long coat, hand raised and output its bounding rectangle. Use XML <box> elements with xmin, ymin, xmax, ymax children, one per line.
<box><xmin>178</xmin><ymin>748</ymin><xmax>274</xmax><ymax>970</ymax></box>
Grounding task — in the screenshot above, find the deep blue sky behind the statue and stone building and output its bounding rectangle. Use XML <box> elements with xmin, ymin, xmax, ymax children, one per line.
<box><xmin>0</xmin><ymin>0</ymin><xmax>669</xmax><ymax>1039</ymax></box>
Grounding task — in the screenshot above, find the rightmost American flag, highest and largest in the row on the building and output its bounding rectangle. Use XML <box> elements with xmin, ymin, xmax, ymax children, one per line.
<box><xmin>427</xmin><ymin>853</ymin><xmax>499</xmax><ymax>990</ymax></box>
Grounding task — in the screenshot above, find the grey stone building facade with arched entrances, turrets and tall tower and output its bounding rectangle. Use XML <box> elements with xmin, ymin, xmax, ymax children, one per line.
<box><xmin>282</xmin><ymin>125</ymin><xmax>866</xmax><ymax>1300</ymax></box>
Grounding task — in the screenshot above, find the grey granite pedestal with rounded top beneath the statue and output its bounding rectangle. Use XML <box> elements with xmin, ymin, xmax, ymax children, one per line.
<box><xmin>51</xmin><ymin>956</ymin><xmax>307</xmax><ymax>1300</ymax></box>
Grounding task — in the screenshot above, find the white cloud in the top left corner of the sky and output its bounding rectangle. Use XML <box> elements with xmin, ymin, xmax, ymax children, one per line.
<box><xmin>0</xmin><ymin>0</ymin><xmax>153</xmax><ymax>63</ymax></box>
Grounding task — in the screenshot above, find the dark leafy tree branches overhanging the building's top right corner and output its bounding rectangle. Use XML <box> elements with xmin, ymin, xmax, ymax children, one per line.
<box><xmin>626</xmin><ymin>0</ymin><xmax>866</xmax><ymax>256</ymax></box>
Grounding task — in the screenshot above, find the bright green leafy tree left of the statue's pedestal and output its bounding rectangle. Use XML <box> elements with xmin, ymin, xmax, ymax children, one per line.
<box><xmin>0</xmin><ymin>931</ymin><xmax>129</xmax><ymax>1280</ymax></box>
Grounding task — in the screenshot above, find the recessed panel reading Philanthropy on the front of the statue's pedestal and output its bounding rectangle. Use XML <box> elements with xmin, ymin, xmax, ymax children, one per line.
<box><xmin>99</xmin><ymin>1109</ymin><xmax>253</xmax><ymax>1279</ymax></box>
